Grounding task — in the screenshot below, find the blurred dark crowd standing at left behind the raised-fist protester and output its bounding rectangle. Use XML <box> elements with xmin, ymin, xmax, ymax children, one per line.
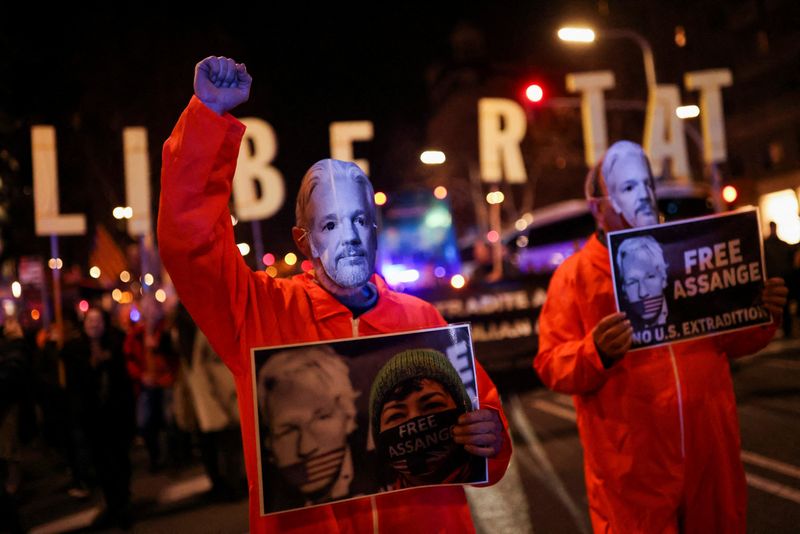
<box><xmin>0</xmin><ymin>297</ymin><xmax>247</xmax><ymax>532</ymax></box>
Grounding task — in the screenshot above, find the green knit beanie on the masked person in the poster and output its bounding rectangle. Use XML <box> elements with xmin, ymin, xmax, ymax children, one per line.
<box><xmin>369</xmin><ymin>349</ymin><xmax>472</xmax><ymax>440</ymax></box>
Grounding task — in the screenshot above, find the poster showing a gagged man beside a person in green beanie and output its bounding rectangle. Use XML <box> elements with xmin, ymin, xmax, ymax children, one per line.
<box><xmin>251</xmin><ymin>324</ymin><xmax>488</xmax><ymax>515</ymax></box>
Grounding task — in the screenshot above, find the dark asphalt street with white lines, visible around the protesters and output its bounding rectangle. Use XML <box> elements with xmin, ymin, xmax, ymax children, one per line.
<box><xmin>17</xmin><ymin>339</ymin><xmax>800</xmax><ymax>534</ymax></box>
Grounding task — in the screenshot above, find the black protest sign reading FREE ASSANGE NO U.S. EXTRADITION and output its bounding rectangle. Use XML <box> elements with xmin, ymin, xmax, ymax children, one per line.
<box><xmin>608</xmin><ymin>208</ymin><xmax>771</xmax><ymax>350</ymax></box>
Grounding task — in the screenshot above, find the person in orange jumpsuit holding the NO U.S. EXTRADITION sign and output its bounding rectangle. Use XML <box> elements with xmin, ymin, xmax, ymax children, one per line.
<box><xmin>534</xmin><ymin>141</ymin><xmax>786</xmax><ymax>533</ymax></box>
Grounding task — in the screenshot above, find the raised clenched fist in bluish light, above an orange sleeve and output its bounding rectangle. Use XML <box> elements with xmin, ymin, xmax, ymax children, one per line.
<box><xmin>194</xmin><ymin>56</ymin><xmax>253</xmax><ymax>115</ymax></box>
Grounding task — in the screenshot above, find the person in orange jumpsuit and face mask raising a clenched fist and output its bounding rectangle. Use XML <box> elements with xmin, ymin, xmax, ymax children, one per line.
<box><xmin>158</xmin><ymin>57</ymin><xmax>511</xmax><ymax>534</ymax></box>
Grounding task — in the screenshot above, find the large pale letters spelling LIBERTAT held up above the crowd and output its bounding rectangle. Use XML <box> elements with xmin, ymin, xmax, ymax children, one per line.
<box><xmin>31</xmin><ymin>69</ymin><xmax>732</xmax><ymax>236</ymax></box>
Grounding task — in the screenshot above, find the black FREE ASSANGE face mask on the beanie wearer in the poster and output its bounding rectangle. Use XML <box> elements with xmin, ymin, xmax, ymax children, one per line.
<box><xmin>378</xmin><ymin>409</ymin><xmax>466</xmax><ymax>483</ymax></box>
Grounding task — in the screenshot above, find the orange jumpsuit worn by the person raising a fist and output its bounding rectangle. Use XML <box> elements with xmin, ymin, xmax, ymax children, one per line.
<box><xmin>158</xmin><ymin>97</ymin><xmax>511</xmax><ymax>534</ymax></box>
